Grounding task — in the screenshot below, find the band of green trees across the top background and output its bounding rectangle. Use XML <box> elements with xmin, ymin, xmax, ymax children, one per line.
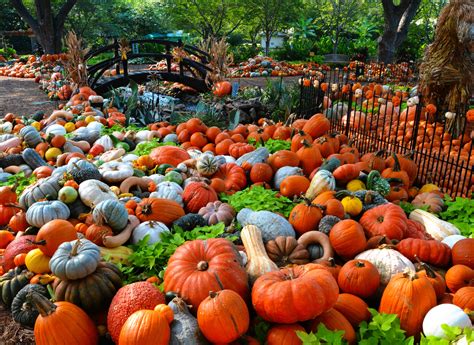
<box><xmin>0</xmin><ymin>0</ymin><xmax>447</xmax><ymax>62</ymax></box>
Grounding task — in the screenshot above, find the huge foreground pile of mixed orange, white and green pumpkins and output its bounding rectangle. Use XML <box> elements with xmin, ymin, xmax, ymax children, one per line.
<box><xmin>0</xmin><ymin>100</ymin><xmax>474</xmax><ymax>345</ymax></box>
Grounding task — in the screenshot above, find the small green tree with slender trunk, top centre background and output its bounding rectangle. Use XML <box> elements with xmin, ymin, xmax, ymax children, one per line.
<box><xmin>247</xmin><ymin>0</ymin><xmax>301</xmax><ymax>55</ymax></box>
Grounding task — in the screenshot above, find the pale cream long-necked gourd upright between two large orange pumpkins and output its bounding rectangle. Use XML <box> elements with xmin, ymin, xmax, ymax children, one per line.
<box><xmin>240</xmin><ymin>225</ymin><xmax>278</xmax><ymax>283</ymax></box>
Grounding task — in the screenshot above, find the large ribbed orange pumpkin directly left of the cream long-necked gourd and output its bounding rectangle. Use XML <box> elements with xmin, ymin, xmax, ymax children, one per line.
<box><xmin>164</xmin><ymin>238</ymin><xmax>248</xmax><ymax>311</ymax></box>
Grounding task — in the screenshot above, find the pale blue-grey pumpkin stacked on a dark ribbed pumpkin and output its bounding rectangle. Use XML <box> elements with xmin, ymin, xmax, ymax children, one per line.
<box><xmin>49</xmin><ymin>239</ymin><xmax>100</xmax><ymax>280</ymax></box>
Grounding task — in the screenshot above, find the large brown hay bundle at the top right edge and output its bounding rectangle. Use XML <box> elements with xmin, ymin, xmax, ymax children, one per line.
<box><xmin>420</xmin><ymin>0</ymin><xmax>474</xmax><ymax>133</ymax></box>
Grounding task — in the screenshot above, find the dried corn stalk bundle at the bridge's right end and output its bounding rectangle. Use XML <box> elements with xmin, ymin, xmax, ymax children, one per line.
<box><xmin>199</xmin><ymin>37</ymin><xmax>233</xmax><ymax>84</ymax></box>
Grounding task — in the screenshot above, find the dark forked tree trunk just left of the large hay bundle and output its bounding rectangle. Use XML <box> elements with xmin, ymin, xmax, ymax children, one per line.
<box><xmin>378</xmin><ymin>0</ymin><xmax>421</xmax><ymax>63</ymax></box>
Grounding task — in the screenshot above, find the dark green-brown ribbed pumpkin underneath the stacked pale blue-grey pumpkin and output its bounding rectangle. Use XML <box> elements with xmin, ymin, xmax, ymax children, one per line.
<box><xmin>53</xmin><ymin>262</ymin><xmax>122</xmax><ymax>313</ymax></box>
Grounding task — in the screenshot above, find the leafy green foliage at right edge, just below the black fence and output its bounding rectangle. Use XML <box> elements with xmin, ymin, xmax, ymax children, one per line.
<box><xmin>440</xmin><ymin>195</ymin><xmax>474</xmax><ymax>237</ymax></box>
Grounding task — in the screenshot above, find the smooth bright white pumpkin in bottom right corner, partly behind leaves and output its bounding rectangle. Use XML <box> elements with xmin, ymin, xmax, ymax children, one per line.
<box><xmin>423</xmin><ymin>303</ymin><xmax>472</xmax><ymax>338</ymax></box>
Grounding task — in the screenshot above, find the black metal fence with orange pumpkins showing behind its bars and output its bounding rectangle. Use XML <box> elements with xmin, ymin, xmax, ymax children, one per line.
<box><xmin>299</xmin><ymin>71</ymin><xmax>474</xmax><ymax>197</ymax></box>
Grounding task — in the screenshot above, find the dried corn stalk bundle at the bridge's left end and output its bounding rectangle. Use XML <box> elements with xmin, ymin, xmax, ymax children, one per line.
<box><xmin>64</xmin><ymin>31</ymin><xmax>89</xmax><ymax>90</ymax></box>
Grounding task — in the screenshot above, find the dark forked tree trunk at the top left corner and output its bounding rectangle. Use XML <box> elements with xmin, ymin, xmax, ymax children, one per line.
<box><xmin>10</xmin><ymin>0</ymin><xmax>77</xmax><ymax>54</ymax></box>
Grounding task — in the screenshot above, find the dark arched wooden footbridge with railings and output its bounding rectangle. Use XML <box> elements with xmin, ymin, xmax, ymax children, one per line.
<box><xmin>85</xmin><ymin>39</ymin><xmax>211</xmax><ymax>94</ymax></box>
